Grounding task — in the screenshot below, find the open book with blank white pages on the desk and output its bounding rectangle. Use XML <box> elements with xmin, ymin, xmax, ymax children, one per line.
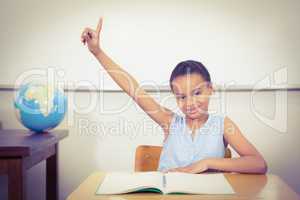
<box><xmin>96</xmin><ymin>171</ymin><xmax>234</xmax><ymax>194</ymax></box>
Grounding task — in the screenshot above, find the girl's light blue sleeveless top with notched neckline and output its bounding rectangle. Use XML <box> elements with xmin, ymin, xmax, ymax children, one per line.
<box><xmin>158</xmin><ymin>113</ymin><xmax>225</xmax><ymax>171</ymax></box>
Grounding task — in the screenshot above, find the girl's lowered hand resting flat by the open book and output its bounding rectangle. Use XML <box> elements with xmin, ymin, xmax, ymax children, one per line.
<box><xmin>167</xmin><ymin>160</ymin><xmax>208</xmax><ymax>174</ymax></box>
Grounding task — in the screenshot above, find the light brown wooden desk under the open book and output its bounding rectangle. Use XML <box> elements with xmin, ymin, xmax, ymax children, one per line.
<box><xmin>67</xmin><ymin>172</ymin><xmax>299</xmax><ymax>200</ymax></box>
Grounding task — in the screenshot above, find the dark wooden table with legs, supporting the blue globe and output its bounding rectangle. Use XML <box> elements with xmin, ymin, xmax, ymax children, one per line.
<box><xmin>0</xmin><ymin>130</ymin><xmax>68</xmax><ymax>200</ymax></box>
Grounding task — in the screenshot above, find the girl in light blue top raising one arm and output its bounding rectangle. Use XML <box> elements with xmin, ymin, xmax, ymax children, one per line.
<box><xmin>81</xmin><ymin>18</ymin><xmax>267</xmax><ymax>173</ymax></box>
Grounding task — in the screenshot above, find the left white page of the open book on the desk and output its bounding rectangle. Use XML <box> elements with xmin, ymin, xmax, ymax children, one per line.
<box><xmin>96</xmin><ymin>172</ymin><xmax>163</xmax><ymax>194</ymax></box>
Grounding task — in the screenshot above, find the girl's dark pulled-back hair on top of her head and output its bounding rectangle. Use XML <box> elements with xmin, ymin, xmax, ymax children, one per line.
<box><xmin>169</xmin><ymin>60</ymin><xmax>211</xmax><ymax>90</ymax></box>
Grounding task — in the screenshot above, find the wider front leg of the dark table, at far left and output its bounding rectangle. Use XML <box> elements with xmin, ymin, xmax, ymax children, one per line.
<box><xmin>7</xmin><ymin>158</ymin><xmax>26</xmax><ymax>200</ymax></box>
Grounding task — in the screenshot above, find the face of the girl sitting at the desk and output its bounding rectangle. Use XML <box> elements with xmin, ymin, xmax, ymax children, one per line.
<box><xmin>171</xmin><ymin>73</ymin><xmax>213</xmax><ymax>119</ymax></box>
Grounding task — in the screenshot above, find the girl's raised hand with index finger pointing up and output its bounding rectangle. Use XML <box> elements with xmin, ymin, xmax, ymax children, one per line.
<box><xmin>81</xmin><ymin>17</ymin><xmax>103</xmax><ymax>55</ymax></box>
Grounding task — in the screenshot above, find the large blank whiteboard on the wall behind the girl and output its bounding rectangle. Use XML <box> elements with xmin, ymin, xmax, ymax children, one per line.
<box><xmin>0</xmin><ymin>0</ymin><xmax>300</xmax><ymax>89</ymax></box>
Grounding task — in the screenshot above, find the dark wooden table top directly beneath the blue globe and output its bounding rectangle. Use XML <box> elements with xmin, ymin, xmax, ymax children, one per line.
<box><xmin>0</xmin><ymin>129</ymin><xmax>68</xmax><ymax>157</ymax></box>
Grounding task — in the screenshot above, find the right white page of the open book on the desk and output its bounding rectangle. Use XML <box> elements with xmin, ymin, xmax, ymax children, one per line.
<box><xmin>165</xmin><ymin>172</ymin><xmax>234</xmax><ymax>194</ymax></box>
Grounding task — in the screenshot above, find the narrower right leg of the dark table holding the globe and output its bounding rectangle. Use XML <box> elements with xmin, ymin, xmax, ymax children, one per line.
<box><xmin>46</xmin><ymin>144</ymin><xmax>59</xmax><ymax>200</ymax></box>
